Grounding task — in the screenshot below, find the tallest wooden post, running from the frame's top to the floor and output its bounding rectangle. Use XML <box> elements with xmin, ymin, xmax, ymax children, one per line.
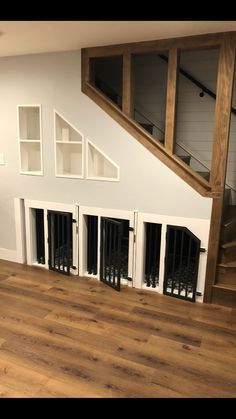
<box><xmin>204</xmin><ymin>34</ymin><xmax>236</xmax><ymax>302</ymax></box>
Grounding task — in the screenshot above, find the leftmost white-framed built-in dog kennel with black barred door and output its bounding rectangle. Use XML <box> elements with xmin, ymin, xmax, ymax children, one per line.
<box><xmin>25</xmin><ymin>200</ymin><xmax>78</xmax><ymax>275</ymax></box>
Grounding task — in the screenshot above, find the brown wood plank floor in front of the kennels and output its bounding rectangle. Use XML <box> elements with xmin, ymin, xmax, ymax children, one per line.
<box><xmin>0</xmin><ymin>261</ymin><xmax>236</xmax><ymax>398</ymax></box>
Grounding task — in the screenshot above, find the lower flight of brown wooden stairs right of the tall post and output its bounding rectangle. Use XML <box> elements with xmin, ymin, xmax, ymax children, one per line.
<box><xmin>212</xmin><ymin>205</ymin><xmax>236</xmax><ymax>307</ymax></box>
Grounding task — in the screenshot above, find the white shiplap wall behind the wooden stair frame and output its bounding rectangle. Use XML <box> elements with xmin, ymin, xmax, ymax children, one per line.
<box><xmin>135</xmin><ymin>49</ymin><xmax>236</xmax><ymax>203</ymax></box>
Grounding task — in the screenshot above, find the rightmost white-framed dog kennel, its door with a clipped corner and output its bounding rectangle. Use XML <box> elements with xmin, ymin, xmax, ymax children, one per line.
<box><xmin>134</xmin><ymin>212</ymin><xmax>209</xmax><ymax>301</ymax></box>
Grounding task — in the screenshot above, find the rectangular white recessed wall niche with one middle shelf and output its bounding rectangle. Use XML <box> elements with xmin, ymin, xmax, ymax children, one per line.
<box><xmin>17</xmin><ymin>105</ymin><xmax>43</xmax><ymax>175</ymax></box>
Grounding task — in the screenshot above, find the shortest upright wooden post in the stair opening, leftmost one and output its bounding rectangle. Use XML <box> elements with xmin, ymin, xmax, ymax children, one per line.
<box><xmin>122</xmin><ymin>52</ymin><xmax>133</xmax><ymax>117</ymax></box>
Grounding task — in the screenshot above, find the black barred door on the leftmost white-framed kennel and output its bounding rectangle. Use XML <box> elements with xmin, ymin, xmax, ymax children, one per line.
<box><xmin>48</xmin><ymin>211</ymin><xmax>73</xmax><ymax>275</ymax></box>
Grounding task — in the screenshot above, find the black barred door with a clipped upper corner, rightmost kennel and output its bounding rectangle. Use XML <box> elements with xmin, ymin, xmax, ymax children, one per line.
<box><xmin>163</xmin><ymin>226</ymin><xmax>201</xmax><ymax>301</ymax></box>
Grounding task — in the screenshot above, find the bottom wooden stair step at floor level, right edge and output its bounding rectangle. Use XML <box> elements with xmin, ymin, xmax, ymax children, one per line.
<box><xmin>212</xmin><ymin>284</ymin><xmax>236</xmax><ymax>308</ymax></box>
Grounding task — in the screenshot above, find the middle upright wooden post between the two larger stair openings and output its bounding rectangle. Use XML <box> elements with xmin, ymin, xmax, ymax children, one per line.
<box><xmin>165</xmin><ymin>48</ymin><xmax>178</xmax><ymax>153</ymax></box>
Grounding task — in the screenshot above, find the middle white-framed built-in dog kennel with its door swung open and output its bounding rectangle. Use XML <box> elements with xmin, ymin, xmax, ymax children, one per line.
<box><xmin>79</xmin><ymin>208</ymin><xmax>134</xmax><ymax>291</ymax></box>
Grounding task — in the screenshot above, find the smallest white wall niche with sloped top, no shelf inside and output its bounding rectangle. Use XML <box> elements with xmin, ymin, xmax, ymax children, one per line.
<box><xmin>86</xmin><ymin>139</ymin><xmax>119</xmax><ymax>181</ymax></box>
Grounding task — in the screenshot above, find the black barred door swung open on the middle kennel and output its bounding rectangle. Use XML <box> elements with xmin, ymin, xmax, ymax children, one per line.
<box><xmin>100</xmin><ymin>217</ymin><xmax>123</xmax><ymax>291</ymax></box>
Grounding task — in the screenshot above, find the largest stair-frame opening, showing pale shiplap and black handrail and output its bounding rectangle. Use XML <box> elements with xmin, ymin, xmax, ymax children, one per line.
<box><xmin>174</xmin><ymin>48</ymin><xmax>219</xmax><ymax>180</ymax></box>
